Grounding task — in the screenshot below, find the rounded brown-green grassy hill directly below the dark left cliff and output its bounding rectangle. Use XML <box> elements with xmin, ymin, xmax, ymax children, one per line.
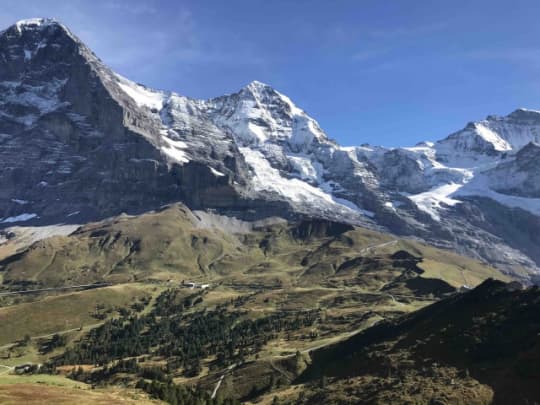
<box><xmin>3</xmin><ymin>206</ymin><xmax>247</xmax><ymax>286</ymax></box>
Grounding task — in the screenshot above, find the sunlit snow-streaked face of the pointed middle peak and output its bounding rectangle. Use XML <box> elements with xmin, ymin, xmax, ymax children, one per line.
<box><xmin>203</xmin><ymin>81</ymin><xmax>382</xmax><ymax>222</ymax></box>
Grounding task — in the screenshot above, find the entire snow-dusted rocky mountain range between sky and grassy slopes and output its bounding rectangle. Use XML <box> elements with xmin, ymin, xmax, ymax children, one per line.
<box><xmin>0</xmin><ymin>19</ymin><xmax>540</xmax><ymax>274</ymax></box>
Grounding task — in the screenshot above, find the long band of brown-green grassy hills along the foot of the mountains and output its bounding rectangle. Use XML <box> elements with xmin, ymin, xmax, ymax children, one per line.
<box><xmin>0</xmin><ymin>204</ymin><xmax>504</xmax><ymax>290</ymax></box>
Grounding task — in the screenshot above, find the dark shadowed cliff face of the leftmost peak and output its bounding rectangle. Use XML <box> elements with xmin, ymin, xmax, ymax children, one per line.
<box><xmin>0</xmin><ymin>20</ymin><xmax>171</xmax><ymax>218</ymax></box>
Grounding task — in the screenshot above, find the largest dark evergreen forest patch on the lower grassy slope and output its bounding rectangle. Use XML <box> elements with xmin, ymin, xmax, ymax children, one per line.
<box><xmin>48</xmin><ymin>290</ymin><xmax>319</xmax><ymax>379</ymax></box>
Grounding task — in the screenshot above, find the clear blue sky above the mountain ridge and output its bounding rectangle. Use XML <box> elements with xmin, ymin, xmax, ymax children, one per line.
<box><xmin>0</xmin><ymin>0</ymin><xmax>540</xmax><ymax>146</ymax></box>
